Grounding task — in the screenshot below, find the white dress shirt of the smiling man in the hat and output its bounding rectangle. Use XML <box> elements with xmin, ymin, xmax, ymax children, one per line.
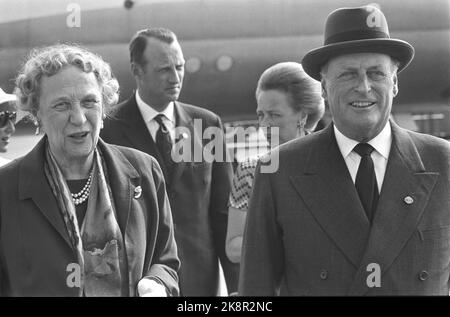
<box><xmin>334</xmin><ymin>121</ymin><xmax>392</xmax><ymax>192</ymax></box>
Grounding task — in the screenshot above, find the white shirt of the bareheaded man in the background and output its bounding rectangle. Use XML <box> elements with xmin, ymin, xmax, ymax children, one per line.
<box><xmin>136</xmin><ymin>91</ymin><xmax>175</xmax><ymax>142</ymax></box>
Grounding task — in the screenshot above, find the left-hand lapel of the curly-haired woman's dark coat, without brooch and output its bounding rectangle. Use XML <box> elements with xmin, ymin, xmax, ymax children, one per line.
<box><xmin>19</xmin><ymin>137</ymin><xmax>73</xmax><ymax>249</ymax></box>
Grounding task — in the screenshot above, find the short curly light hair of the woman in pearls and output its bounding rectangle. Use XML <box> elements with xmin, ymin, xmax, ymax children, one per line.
<box><xmin>14</xmin><ymin>44</ymin><xmax>119</xmax><ymax>117</ymax></box>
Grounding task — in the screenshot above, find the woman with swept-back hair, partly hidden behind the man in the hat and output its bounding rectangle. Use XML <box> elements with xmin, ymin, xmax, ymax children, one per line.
<box><xmin>225</xmin><ymin>62</ymin><xmax>325</xmax><ymax>263</ymax></box>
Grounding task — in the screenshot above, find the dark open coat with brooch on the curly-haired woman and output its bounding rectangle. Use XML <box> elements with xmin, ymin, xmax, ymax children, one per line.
<box><xmin>0</xmin><ymin>137</ymin><xmax>180</xmax><ymax>296</ymax></box>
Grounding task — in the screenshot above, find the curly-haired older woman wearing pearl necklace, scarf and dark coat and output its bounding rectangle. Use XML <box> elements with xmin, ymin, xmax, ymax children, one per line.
<box><xmin>0</xmin><ymin>45</ymin><xmax>180</xmax><ymax>296</ymax></box>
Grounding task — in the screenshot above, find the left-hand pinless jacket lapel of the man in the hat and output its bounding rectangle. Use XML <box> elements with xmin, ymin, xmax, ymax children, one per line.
<box><xmin>291</xmin><ymin>125</ymin><xmax>370</xmax><ymax>268</ymax></box>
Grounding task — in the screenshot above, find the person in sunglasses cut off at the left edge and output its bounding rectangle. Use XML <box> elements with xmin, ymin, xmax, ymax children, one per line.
<box><xmin>0</xmin><ymin>88</ymin><xmax>17</xmax><ymax>166</ymax></box>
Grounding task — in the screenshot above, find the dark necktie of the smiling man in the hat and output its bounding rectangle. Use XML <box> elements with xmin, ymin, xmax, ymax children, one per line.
<box><xmin>353</xmin><ymin>143</ymin><xmax>379</xmax><ymax>222</ymax></box>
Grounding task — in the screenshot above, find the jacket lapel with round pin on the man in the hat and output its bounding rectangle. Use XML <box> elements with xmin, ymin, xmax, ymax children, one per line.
<box><xmin>349</xmin><ymin>122</ymin><xmax>439</xmax><ymax>295</ymax></box>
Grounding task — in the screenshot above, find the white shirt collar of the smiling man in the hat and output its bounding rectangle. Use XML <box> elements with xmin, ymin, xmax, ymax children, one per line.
<box><xmin>333</xmin><ymin>120</ymin><xmax>392</xmax><ymax>160</ymax></box>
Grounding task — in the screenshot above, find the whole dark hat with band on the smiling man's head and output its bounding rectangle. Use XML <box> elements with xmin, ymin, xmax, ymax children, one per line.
<box><xmin>302</xmin><ymin>6</ymin><xmax>414</xmax><ymax>80</ymax></box>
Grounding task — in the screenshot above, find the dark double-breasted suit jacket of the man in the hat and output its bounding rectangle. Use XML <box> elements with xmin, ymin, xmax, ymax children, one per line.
<box><xmin>239</xmin><ymin>122</ymin><xmax>450</xmax><ymax>296</ymax></box>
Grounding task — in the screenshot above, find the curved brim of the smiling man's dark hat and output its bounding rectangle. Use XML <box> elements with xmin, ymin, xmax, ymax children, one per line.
<box><xmin>302</xmin><ymin>39</ymin><xmax>414</xmax><ymax>81</ymax></box>
